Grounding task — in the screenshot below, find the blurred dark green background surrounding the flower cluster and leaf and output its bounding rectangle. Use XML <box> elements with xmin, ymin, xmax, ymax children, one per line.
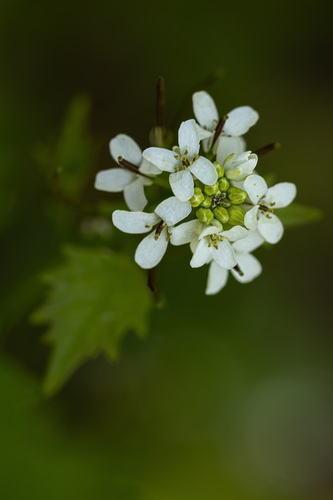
<box><xmin>0</xmin><ymin>0</ymin><xmax>333</xmax><ymax>500</ymax></box>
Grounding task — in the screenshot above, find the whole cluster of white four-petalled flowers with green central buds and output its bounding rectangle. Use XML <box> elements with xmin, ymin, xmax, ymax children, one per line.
<box><xmin>95</xmin><ymin>91</ymin><xmax>296</xmax><ymax>295</ymax></box>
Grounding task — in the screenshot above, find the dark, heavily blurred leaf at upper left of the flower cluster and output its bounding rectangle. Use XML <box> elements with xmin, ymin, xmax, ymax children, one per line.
<box><xmin>35</xmin><ymin>95</ymin><xmax>96</xmax><ymax>201</ymax></box>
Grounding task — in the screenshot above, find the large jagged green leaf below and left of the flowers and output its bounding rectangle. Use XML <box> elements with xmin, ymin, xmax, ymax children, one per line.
<box><xmin>32</xmin><ymin>247</ymin><xmax>151</xmax><ymax>394</ymax></box>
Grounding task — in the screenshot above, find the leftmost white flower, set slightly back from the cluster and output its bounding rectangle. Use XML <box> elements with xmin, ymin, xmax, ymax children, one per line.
<box><xmin>95</xmin><ymin>134</ymin><xmax>161</xmax><ymax>210</ymax></box>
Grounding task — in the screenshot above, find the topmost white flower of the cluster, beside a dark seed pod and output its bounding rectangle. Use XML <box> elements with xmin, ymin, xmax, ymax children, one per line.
<box><xmin>193</xmin><ymin>91</ymin><xmax>259</xmax><ymax>165</ymax></box>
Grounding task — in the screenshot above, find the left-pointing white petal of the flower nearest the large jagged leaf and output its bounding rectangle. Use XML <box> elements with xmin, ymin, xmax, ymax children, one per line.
<box><xmin>112</xmin><ymin>210</ymin><xmax>160</xmax><ymax>234</ymax></box>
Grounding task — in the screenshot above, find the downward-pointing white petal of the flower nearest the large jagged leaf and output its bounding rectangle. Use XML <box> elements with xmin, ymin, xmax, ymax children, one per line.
<box><xmin>134</xmin><ymin>227</ymin><xmax>168</xmax><ymax>269</ymax></box>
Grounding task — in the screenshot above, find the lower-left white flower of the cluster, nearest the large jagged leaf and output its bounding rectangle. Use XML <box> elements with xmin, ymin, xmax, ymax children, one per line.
<box><xmin>112</xmin><ymin>196</ymin><xmax>192</xmax><ymax>269</ymax></box>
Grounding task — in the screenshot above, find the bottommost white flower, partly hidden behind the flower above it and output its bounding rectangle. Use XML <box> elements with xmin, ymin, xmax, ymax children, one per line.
<box><xmin>206</xmin><ymin>231</ymin><xmax>265</xmax><ymax>295</ymax></box>
